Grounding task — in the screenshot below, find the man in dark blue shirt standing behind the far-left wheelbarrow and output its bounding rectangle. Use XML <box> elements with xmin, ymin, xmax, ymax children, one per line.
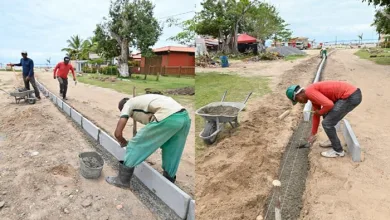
<box><xmin>11</xmin><ymin>51</ymin><xmax>41</xmax><ymax>99</ymax></box>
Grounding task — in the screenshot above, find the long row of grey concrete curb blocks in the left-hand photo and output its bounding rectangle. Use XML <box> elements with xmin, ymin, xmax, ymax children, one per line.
<box><xmin>36</xmin><ymin>80</ymin><xmax>195</xmax><ymax>220</ymax></box>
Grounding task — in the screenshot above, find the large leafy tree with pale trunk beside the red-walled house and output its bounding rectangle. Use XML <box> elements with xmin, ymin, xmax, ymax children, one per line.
<box><xmin>101</xmin><ymin>0</ymin><xmax>162</xmax><ymax>76</ymax></box>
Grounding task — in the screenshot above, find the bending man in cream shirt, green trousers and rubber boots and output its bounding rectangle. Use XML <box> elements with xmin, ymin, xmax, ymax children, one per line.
<box><xmin>106</xmin><ymin>94</ymin><xmax>191</xmax><ymax>187</ymax></box>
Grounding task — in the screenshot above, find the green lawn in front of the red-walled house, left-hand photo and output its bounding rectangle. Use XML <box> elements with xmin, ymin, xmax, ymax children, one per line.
<box><xmin>77</xmin><ymin>74</ymin><xmax>195</xmax><ymax>105</ymax></box>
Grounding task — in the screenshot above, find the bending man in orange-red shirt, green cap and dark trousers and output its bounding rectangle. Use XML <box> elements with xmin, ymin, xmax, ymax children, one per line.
<box><xmin>286</xmin><ymin>81</ymin><xmax>362</xmax><ymax>157</ymax></box>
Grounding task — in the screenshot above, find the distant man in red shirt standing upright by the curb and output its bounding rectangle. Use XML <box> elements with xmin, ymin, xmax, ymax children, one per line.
<box><xmin>53</xmin><ymin>56</ymin><xmax>76</xmax><ymax>100</ymax></box>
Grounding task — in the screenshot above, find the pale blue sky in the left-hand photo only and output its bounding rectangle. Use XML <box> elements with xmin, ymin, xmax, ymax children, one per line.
<box><xmin>0</xmin><ymin>0</ymin><xmax>199</xmax><ymax>65</ymax></box>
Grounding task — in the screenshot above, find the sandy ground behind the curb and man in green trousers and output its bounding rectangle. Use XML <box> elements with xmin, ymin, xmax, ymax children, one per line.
<box><xmin>33</xmin><ymin>72</ymin><xmax>195</xmax><ymax>195</ymax></box>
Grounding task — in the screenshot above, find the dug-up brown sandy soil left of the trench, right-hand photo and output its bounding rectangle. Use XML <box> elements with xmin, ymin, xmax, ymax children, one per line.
<box><xmin>195</xmin><ymin>57</ymin><xmax>319</xmax><ymax>220</ymax></box>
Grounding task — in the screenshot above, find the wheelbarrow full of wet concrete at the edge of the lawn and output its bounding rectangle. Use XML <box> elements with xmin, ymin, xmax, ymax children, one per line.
<box><xmin>195</xmin><ymin>91</ymin><xmax>252</xmax><ymax>145</ymax></box>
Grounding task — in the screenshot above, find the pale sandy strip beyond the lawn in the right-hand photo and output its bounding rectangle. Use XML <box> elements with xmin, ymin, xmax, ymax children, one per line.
<box><xmin>196</xmin><ymin>50</ymin><xmax>319</xmax><ymax>89</ymax></box>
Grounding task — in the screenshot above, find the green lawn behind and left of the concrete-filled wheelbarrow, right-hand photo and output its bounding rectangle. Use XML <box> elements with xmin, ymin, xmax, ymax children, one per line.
<box><xmin>195</xmin><ymin>73</ymin><xmax>271</xmax><ymax>155</ymax></box>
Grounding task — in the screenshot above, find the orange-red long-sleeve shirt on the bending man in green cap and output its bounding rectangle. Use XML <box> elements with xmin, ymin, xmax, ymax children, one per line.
<box><xmin>305</xmin><ymin>81</ymin><xmax>357</xmax><ymax>135</ymax></box>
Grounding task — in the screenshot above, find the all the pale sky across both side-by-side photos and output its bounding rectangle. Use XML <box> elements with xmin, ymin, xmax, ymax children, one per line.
<box><xmin>0</xmin><ymin>0</ymin><xmax>378</xmax><ymax>64</ymax></box>
